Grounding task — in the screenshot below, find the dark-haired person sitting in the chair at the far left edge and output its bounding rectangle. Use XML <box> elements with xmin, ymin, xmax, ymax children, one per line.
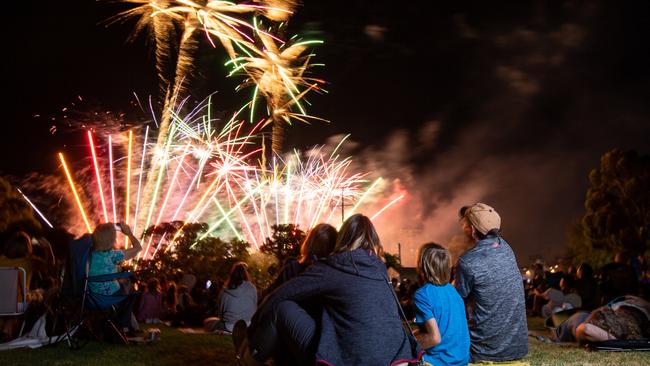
<box><xmin>0</xmin><ymin>231</ymin><xmax>54</xmax><ymax>343</ymax></box>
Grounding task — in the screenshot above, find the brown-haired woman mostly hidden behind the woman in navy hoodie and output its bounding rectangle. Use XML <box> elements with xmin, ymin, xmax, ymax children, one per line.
<box><xmin>261</xmin><ymin>224</ymin><xmax>337</xmax><ymax>300</ymax></box>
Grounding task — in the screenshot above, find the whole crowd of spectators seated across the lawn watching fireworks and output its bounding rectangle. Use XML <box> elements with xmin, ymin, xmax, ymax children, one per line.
<box><xmin>0</xmin><ymin>199</ymin><xmax>650</xmax><ymax>365</ymax></box>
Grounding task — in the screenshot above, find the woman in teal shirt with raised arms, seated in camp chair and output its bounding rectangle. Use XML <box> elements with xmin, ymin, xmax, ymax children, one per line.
<box><xmin>88</xmin><ymin>223</ymin><xmax>142</xmax><ymax>331</ymax></box>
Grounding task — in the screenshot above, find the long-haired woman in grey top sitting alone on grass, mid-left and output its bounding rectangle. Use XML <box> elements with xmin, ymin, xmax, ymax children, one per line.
<box><xmin>203</xmin><ymin>262</ymin><xmax>257</xmax><ymax>332</ymax></box>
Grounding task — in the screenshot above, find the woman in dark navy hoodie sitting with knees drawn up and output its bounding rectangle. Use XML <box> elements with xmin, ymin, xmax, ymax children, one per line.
<box><xmin>233</xmin><ymin>214</ymin><xmax>418</xmax><ymax>366</ymax></box>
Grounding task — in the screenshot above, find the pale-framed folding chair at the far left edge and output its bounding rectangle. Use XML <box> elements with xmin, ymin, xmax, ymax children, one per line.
<box><xmin>0</xmin><ymin>267</ymin><xmax>27</xmax><ymax>335</ymax></box>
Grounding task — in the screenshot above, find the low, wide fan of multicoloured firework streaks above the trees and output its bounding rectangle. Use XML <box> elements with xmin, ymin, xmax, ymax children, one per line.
<box><xmin>54</xmin><ymin>100</ymin><xmax>398</xmax><ymax>258</ymax></box>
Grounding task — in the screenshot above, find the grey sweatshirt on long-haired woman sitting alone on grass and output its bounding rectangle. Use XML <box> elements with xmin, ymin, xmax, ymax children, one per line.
<box><xmin>219</xmin><ymin>281</ymin><xmax>257</xmax><ymax>332</ymax></box>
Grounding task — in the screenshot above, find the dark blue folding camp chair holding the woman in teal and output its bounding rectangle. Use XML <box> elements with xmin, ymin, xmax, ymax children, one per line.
<box><xmin>53</xmin><ymin>234</ymin><xmax>135</xmax><ymax>348</ymax></box>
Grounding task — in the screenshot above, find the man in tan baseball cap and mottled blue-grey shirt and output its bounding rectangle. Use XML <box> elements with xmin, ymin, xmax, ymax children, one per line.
<box><xmin>454</xmin><ymin>203</ymin><xmax>528</xmax><ymax>362</ymax></box>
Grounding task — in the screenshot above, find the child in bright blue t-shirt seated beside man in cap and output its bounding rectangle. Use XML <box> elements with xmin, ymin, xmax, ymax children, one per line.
<box><xmin>413</xmin><ymin>243</ymin><xmax>470</xmax><ymax>365</ymax></box>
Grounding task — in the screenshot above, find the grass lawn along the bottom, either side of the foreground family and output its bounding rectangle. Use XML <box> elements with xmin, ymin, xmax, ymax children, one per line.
<box><xmin>0</xmin><ymin>318</ymin><xmax>650</xmax><ymax>366</ymax></box>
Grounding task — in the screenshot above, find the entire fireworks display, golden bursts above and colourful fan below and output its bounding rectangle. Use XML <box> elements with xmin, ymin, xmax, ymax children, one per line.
<box><xmin>46</xmin><ymin>0</ymin><xmax>401</xmax><ymax>258</ymax></box>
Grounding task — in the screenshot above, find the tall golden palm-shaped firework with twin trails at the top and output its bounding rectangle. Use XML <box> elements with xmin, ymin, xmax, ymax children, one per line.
<box><xmin>104</xmin><ymin>0</ymin><xmax>302</xmax><ymax>209</ymax></box>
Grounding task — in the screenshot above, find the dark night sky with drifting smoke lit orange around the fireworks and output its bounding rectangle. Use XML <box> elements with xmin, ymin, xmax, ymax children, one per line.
<box><xmin>0</xmin><ymin>0</ymin><xmax>650</xmax><ymax>264</ymax></box>
